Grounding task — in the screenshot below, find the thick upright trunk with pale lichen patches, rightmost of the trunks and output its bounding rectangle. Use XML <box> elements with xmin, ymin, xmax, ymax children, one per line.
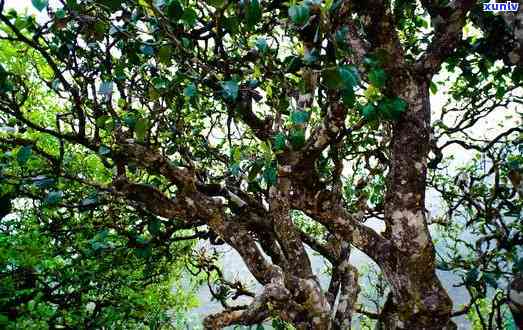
<box><xmin>383</xmin><ymin>72</ymin><xmax>452</xmax><ymax>329</ymax></box>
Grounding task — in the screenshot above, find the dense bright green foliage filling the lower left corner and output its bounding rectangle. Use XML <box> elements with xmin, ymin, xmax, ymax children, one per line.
<box><xmin>0</xmin><ymin>203</ymin><xmax>199</xmax><ymax>329</ymax></box>
